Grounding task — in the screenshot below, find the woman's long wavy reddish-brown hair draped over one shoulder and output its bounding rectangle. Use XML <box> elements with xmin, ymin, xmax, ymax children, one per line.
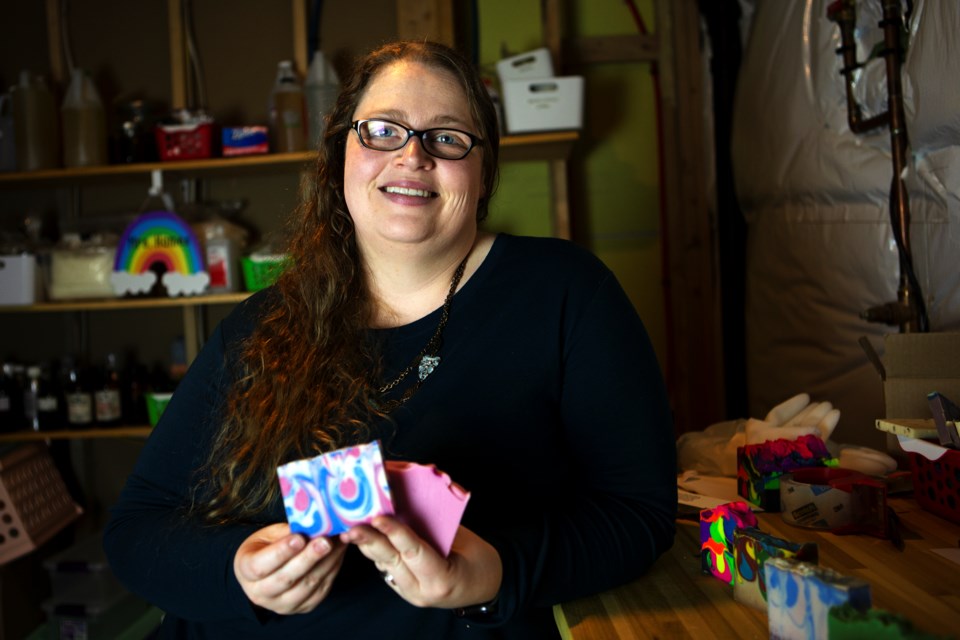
<box><xmin>200</xmin><ymin>41</ymin><xmax>500</xmax><ymax>523</ymax></box>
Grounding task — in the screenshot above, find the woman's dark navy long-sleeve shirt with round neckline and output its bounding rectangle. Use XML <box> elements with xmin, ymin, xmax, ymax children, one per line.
<box><xmin>104</xmin><ymin>235</ymin><xmax>677</xmax><ymax>640</ymax></box>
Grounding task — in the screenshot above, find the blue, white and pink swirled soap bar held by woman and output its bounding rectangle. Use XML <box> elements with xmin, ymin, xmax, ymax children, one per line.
<box><xmin>277</xmin><ymin>441</ymin><xmax>394</xmax><ymax>538</ymax></box>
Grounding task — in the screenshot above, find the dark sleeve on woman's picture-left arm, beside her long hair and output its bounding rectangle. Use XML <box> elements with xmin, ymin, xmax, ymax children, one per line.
<box><xmin>104</xmin><ymin>308</ymin><xmax>261</xmax><ymax>620</ymax></box>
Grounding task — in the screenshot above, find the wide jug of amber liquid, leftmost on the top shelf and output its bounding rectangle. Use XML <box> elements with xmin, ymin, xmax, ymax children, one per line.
<box><xmin>12</xmin><ymin>71</ymin><xmax>60</xmax><ymax>171</ymax></box>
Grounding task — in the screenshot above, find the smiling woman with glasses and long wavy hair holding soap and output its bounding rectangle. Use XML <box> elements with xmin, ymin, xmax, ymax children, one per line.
<box><xmin>105</xmin><ymin>42</ymin><xmax>676</xmax><ymax>639</ymax></box>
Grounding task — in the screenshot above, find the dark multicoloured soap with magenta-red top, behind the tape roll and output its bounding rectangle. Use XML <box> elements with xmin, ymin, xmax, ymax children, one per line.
<box><xmin>737</xmin><ymin>435</ymin><xmax>838</xmax><ymax>512</ymax></box>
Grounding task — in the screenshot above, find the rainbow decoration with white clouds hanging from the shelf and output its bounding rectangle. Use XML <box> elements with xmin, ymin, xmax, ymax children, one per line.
<box><xmin>110</xmin><ymin>211</ymin><xmax>210</xmax><ymax>297</ymax></box>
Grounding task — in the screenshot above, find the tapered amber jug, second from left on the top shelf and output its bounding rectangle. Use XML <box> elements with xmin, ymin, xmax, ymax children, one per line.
<box><xmin>60</xmin><ymin>69</ymin><xmax>107</xmax><ymax>167</ymax></box>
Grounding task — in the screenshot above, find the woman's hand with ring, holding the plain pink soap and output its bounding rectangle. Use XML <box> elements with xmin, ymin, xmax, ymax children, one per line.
<box><xmin>340</xmin><ymin>516</ymin><xmax>503</xmax><ymax>609</ymax></box>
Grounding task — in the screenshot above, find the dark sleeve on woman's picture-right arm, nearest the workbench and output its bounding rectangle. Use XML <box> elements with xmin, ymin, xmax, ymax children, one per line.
<box><xmin>492</xmin><ymin>273</ymin><xmax>677</xmax><ymax>623</ymax></box>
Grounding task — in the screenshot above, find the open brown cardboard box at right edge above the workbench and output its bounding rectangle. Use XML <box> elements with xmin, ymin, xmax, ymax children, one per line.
<box><xmin>883</xmin><ymin>332</ymin><xmax>960</xmax><ymax>459</ymax></box>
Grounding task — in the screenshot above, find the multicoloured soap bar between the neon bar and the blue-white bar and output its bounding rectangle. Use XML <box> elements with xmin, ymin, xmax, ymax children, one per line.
<box><xmin>733</xmin><ymin>527</ymin><xmax>819</xmax><ymax>611</ymax></box>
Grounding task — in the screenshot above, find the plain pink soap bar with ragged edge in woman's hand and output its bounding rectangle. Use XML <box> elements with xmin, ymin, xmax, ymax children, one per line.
<box><xmin>386</xmin><ymin>460</ymin><xmax>470</xmax><ymax>557</ymax></box>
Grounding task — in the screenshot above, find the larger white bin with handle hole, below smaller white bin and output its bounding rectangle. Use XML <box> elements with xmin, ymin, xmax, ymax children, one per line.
<box><xmin>503</xmin><ymin>76</ymin><xmax>583</xmax><ymax>133</ymax></box>
